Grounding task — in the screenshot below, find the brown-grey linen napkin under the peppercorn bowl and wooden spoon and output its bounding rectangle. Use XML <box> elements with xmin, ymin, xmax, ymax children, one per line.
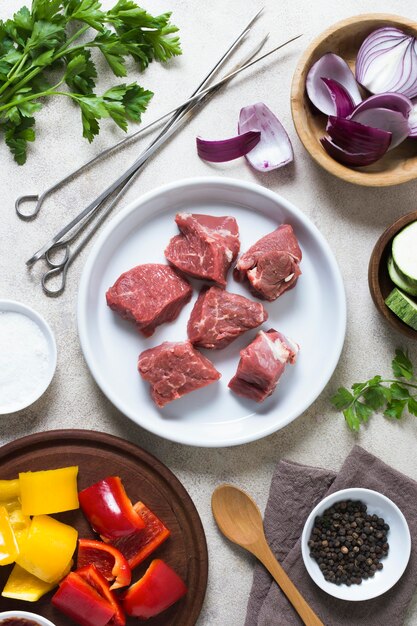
<box><xmin>245</xmin><ymin>446</ymin><xmax>417</xmax><ymax>626</ymax></box>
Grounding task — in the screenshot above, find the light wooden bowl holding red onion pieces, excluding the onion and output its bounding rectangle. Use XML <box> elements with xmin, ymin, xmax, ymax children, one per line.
<box><xmin>291</xmin><ymin>13</ymin><xmax>417</xmax><ymax>187</ymax></box>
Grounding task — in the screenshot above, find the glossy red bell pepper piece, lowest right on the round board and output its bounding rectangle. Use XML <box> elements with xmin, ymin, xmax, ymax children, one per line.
<box><xmin>123</xmin><ymin>559</ymin><xmax>187</xmax><ymax>619</ymax></box>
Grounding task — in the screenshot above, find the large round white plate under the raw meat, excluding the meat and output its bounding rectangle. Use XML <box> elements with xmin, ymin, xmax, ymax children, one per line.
<box><xmin>78</xmin><ymin>177</ymin><xmax>346</xmax><ymax>446</ymax></box>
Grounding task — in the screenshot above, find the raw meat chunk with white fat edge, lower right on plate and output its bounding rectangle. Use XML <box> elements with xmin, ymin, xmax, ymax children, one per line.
<box><xmin>229</xmin><ymin>328</ymin><xmax>299</xmax><ymax>402</ymax></box>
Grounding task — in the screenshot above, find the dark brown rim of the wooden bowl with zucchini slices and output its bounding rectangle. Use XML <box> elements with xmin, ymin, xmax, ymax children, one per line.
<box><xmin>368</xmin><ymin>211</ymin><xmax>417</xmax><ymax>339</ymax></box>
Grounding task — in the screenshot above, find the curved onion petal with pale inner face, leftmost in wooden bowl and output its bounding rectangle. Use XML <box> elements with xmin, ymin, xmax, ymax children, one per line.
<box><xmin>306</xmin><ymin>52</ymin><xmax>360</xmax><ymax>115</ymax></box>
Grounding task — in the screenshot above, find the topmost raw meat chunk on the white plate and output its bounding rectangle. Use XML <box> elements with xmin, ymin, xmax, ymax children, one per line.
<box><xmin>165</xmin><ymin>213</ymin><xmax>240</xmax><ymax>287</ymax></box>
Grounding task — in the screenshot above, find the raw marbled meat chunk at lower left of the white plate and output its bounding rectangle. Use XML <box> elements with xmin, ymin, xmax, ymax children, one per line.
<box><xmin>138</xmin><ymin>341</ymin><xmax>221</xmax><ymax>407</ymax></box>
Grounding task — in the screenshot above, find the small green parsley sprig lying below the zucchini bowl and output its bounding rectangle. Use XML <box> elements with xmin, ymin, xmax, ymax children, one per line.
<box><xmin>331</xmin><ymin>349</ymin><xmax>417</xmax><ymax>432</ymax></box>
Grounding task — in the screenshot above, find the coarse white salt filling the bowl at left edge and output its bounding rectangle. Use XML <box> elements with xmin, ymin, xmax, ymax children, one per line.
<box><xmin>0</xmin><ymin>311</ymin><xmax>50</xmax><ymax>413</ymax></box>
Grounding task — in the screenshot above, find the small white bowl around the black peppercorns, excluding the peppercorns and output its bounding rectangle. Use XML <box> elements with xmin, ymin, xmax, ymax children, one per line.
<box><xmin>301</xmin><ymin>488</ymin><xmax>411</xmax><ymax>601</ymax></box>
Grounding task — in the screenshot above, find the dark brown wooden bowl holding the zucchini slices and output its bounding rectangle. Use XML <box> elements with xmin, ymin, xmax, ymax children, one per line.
<box><xmin>368</xmin><ymin>211</ymin><xmax>417</xmax><ymax>339</ymax></box>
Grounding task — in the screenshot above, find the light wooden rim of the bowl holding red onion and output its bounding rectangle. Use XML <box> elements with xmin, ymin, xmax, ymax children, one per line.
<box><xmin>291</xmin><ymin>13</ymin><xmax>417</xmax><ymax>187</ymax></box>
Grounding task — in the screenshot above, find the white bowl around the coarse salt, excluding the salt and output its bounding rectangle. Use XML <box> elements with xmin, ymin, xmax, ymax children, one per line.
<box><xmin>0</xmin><ymin>300</ymin><xmax>57</xmax><ymax>415</ymax></box>
